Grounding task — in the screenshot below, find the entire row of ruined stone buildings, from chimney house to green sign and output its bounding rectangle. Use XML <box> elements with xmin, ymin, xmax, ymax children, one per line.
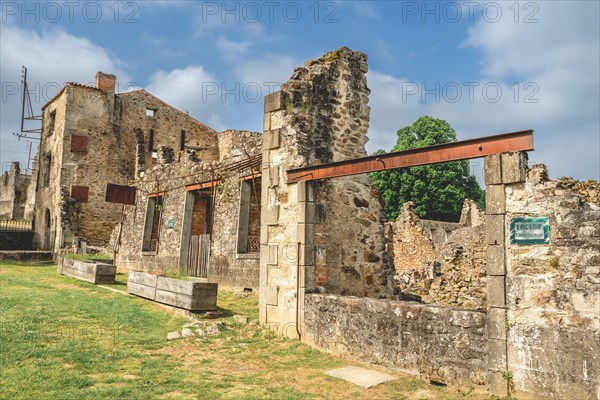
<box><xmin>11</xmin><ymin>48</ymin><xmax>600</xmax><ymax>399</ymax></box>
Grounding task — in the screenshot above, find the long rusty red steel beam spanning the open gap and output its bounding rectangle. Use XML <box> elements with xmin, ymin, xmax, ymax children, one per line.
<box><xmin>287</xmin><ymin>129</ymin><xmax>533</xmax><ymax>183</ymax></box>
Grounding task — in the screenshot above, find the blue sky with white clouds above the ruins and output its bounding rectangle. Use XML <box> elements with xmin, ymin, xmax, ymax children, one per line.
<box><xmin>0</xmin><ymin>1</ymin><xmax>600</xmax><ymax>183</ymax></box>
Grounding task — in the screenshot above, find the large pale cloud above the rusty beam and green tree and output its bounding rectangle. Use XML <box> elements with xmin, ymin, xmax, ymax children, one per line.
<box><xmin>368</xmin><ymin>2</ymin><xmax>600</xmax><ymax>179</ymax></box>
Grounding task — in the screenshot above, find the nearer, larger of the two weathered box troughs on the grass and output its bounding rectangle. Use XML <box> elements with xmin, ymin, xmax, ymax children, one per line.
<box><xmin>127</xmin><ymin>271</ymin><xmax>218</xmax><ymax>311</ymax></box>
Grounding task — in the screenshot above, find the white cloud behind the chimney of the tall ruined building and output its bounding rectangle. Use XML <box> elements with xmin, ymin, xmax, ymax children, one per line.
<box><xmin>0</xmin><ymin>24</ymin><xmax>131</xmax><ymax>167</ymax></box>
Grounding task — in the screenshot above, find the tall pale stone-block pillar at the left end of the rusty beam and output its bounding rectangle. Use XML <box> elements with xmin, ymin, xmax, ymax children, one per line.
<box><xmin>259</xmin><ymin>91</ymin><xmax>304</xmax><ymax>337</ymax></box>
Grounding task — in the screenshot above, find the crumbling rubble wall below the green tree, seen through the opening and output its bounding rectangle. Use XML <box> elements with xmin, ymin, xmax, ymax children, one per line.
<box><xmin>390</xmin><ymin>199</ymin><xmax>486</xmax><ymax>310</ymax></box>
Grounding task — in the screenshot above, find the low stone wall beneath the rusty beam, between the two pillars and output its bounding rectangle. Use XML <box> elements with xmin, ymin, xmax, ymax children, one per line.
<box><xmin>302</xmin><ymin>294</ymin><xmax>488</xmax><ymax>389</ymax></box>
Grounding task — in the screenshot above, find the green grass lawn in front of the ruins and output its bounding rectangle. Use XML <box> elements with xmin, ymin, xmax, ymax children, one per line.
<box><xmin>0</xmin><ymin>264</ymin><xmax>496</xmax><ymax>400</ymax></box>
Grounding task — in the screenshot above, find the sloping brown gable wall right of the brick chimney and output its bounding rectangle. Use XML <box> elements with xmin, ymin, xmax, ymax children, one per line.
<box><xmin>118</xmin><ymin>90</ymin><xmax>219</xmax><ymax>176</ymax></box>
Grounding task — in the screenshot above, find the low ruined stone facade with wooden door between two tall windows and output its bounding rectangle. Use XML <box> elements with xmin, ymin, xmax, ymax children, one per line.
<box><xmin>112</xmin><ymin>130</ymin><xmax>262</xmax><ymax>289</ymax></box>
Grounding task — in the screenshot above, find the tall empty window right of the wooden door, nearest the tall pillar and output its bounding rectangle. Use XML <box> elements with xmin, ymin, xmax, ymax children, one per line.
<box><xmin>237</xmin><ymin>178</ymin><xmax>261</xmax><ymax>254</ymax></box>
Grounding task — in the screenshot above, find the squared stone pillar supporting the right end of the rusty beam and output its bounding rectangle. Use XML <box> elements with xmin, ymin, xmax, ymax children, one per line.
<box><xmin>485</xmin><ymin>152</ymin><xmax>527</xmax><ymax>396</ymax></box>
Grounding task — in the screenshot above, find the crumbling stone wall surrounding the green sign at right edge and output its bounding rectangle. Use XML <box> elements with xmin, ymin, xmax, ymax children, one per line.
<box><xmin>504</xmin><ymin>165</ymin><xmax>600</xmax><ymax>399</ymax></box>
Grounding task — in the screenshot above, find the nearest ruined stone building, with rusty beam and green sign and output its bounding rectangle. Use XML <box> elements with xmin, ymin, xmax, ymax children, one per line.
<box><xmin>254</xmin><ymin>48</ymin><xmax>600</xmax><ymax>399</ymax></box>
